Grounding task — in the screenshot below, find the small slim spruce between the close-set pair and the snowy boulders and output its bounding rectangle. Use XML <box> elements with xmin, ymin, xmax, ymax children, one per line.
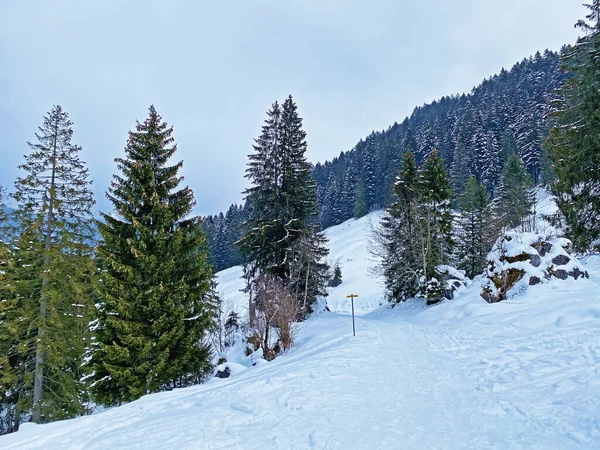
<box><xmin>456</xmin><ymin>177</ymin><xmax>491</xmax><ymax>278</ymax></box>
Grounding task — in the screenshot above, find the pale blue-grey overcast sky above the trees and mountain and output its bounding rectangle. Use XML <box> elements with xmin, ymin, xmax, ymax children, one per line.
<box><xmin>0</xmin><ymin>0</ymin><xmax>585</xmax><ymax>214</ymax></box>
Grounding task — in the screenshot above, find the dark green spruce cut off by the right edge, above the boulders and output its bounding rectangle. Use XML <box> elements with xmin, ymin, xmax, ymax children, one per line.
<box><xmin>546</xmin><ymin>0</ymin><xmax>600</xmax><ymax>251</ymax></box>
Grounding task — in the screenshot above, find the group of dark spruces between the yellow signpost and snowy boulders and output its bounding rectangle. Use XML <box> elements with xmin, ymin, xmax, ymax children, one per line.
<box><xmin>370</xmin><ymin>149</ymin><xmax>535</xmax><ymax>303</ymax></box>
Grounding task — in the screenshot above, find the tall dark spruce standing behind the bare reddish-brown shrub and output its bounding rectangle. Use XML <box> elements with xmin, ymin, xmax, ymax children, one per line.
<box><xmin>238</xmin><ymin>96</ymin><xmax>327</xmax><ymax>315</ymax></box>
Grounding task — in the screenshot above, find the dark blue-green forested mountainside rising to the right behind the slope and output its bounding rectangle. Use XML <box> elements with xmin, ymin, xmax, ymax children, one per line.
<box><xmin>204</xmin><ymin>47</ymin><xmax>568</xmax><ymax>270</ymax></box>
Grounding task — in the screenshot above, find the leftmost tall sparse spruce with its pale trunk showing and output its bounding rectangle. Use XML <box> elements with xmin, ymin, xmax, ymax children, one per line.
<box><xmin>0</xmin><ymin>106</ymin><xmax>94</xmax><ymax>428</ymax></box>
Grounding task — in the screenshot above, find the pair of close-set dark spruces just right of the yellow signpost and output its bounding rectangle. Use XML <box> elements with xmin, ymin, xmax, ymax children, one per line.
<box><xmin>373</xmin><ymin>150</ymin><xmax>454</xmax><ymax>303</ymax></box>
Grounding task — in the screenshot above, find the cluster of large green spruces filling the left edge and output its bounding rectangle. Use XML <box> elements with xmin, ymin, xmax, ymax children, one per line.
<box><xmin>0</xmin><ymin>106</ymin><xmax>215</xmax><ymax>433</ymax></box>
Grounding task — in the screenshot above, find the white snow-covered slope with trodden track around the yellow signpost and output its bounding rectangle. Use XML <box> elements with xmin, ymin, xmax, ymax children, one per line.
<box><xmin>0</xmin><ymin>215</ymin><xmax>600</xmax><ymax>449</ymax></box>
